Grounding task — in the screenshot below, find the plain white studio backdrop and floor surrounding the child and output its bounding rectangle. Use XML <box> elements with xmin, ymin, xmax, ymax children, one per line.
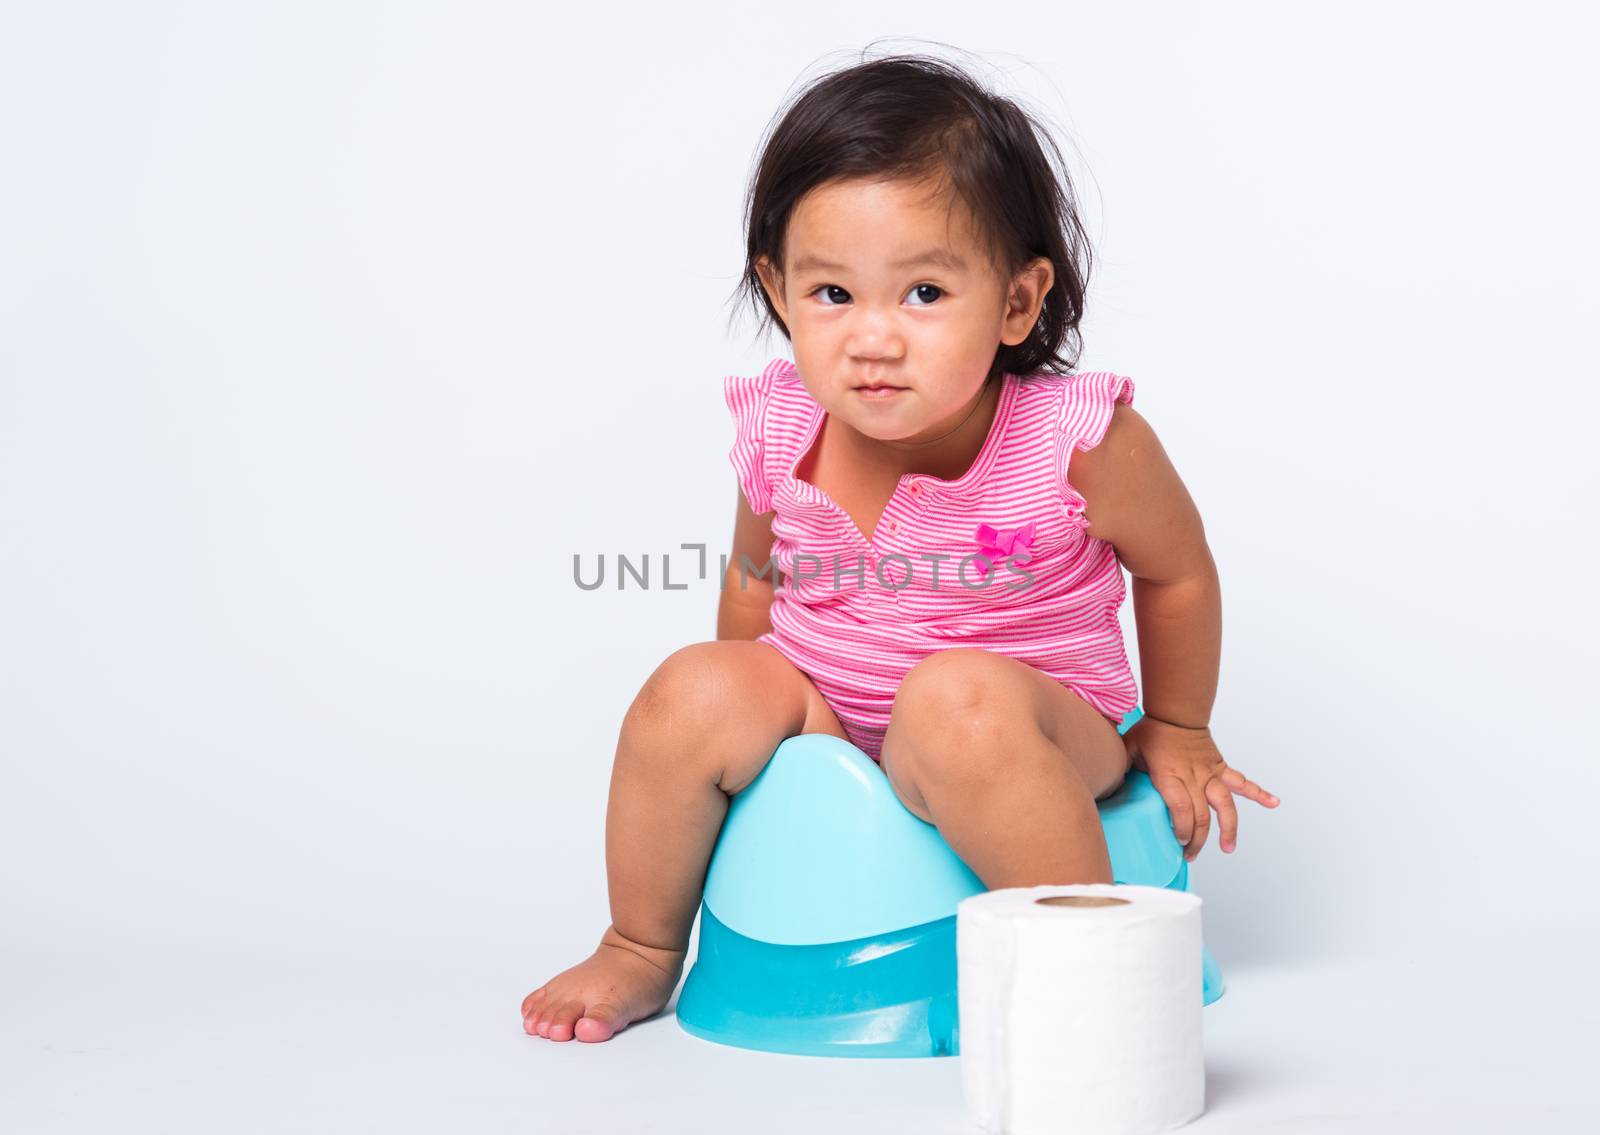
<box><xmin>0</xmin><ymin>0</ymin><xmax>1600</xmax><ymax>1132</ymax></box>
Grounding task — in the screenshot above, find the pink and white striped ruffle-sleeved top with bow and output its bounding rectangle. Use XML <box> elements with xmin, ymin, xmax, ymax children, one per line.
<box><xmin>723</xmin><ymin>359</ymin><xmax>1138</xmax><ymax>760</ymax></box>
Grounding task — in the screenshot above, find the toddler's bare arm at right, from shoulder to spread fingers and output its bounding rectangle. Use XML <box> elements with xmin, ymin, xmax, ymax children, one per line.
<box><xmin>1067</xmin><ymin>402</ymin><xmax>1278</xmax><ymax>860</ymax></box>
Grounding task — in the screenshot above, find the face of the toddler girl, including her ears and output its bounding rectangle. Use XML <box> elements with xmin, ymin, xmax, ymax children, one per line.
<box><xmin>757</xmin><ymin>179</ymin><xmax>1054</xmax><ymax>442</ymax></box>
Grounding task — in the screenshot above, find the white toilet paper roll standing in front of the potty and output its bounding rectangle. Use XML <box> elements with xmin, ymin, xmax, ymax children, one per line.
<box><xmin>955</xmin><ymin>884</ymin><xmax>1205</xmax><ymax>1135</ymax></box>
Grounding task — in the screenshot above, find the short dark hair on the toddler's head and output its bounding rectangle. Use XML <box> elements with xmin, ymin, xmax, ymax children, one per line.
<box><xmin>734</xmin><ymin>54</ymin><xmax>1091</xmax><ymax>376</ymax></box>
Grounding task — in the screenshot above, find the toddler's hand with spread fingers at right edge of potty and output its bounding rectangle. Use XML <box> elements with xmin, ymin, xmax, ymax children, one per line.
<box><xmin>1122</xmin><ymin>716</ymin><xmax>1278</xmax><ymax>860</ymax></box>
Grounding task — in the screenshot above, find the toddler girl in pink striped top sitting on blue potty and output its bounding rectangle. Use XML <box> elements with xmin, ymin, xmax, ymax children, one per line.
<box><xmin>522</xmin><ymin>56</ymin><xmax>1278</xmax><ymax>1041</ymax></box>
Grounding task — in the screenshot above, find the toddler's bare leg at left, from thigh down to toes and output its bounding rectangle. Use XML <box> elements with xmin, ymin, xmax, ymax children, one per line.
<box><xmin>522</xmin><ymin>639</ymin><xmax>845</xmax><ymax>1041</ymax></box>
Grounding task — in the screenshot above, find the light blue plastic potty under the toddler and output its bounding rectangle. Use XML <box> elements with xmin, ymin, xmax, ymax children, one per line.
<box><xmin>677</xmin><ymin>708</ymin><xmax>1222</xmax><ymax>1057</ymax></box>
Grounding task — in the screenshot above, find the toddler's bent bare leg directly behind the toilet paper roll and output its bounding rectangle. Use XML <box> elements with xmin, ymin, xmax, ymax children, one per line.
<box><xmin>882</xmin><ymin>648</ymin><xmax>1128</xmax><ymax>890</ymax></box>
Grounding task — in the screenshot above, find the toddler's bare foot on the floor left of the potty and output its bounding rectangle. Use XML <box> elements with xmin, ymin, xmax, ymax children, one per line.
<box><xmin>522</xmin><ymin>925</ymin><xmax>686</xmax><ymax>1041</ymax></box>
